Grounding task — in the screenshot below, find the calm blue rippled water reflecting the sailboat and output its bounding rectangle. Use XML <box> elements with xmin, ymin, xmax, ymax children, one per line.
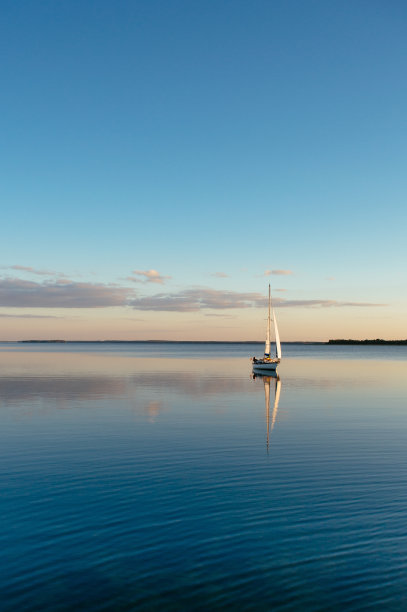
<box><xmin>0</xmin><ymin>344</ymin><xmax>407</xmax><ymax>611</ymax></box>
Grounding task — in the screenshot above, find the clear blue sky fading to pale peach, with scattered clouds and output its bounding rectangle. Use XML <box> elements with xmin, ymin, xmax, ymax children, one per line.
<box><xmin>0</xmin><ymin>0</ymin><xmax>407</xmax><ymax>341</ymax></box>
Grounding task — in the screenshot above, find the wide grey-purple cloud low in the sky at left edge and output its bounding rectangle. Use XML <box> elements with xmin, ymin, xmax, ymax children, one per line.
<box><xmin>0</xmin><ymin>278</ymin><xmax>131</xmax><ymax>308</ymax></box>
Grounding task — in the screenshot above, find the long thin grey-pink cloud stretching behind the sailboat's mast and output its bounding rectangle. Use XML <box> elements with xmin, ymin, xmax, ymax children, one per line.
<box><xmin>129</xmin><ymin>288</ymin><xmax>386</xmax><ymax>312</ymax></box>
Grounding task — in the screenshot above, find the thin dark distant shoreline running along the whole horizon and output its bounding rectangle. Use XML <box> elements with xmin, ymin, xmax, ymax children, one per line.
<box><xmin>4</xmin><ymin>338</ymin><xmax>407</xmax><ymax>346</ymax></box>
